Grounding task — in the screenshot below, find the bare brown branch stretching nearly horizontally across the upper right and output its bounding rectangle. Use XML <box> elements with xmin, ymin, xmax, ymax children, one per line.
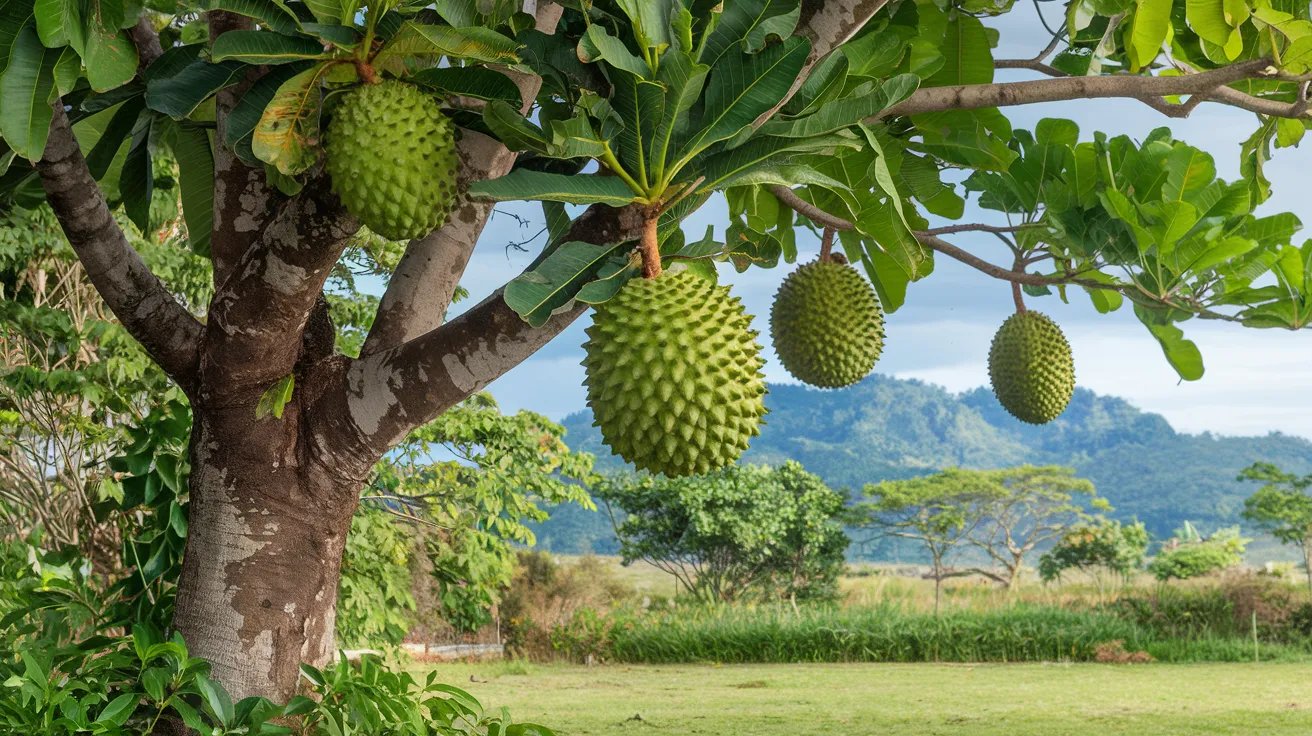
<box><xmin>870</xmin><ymin>59</ymin><xmax>1307</xmax><ymax>122</ymax></box>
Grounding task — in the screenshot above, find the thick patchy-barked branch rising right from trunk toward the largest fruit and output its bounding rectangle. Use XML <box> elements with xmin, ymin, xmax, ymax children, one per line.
<box><xmin>329</xmin><ymin>205</ymin><xmax>642</xmax><ymax>454</ymax></box>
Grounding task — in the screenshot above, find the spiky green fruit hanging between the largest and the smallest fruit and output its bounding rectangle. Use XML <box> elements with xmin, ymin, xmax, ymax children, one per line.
<box><xmin>770</xmin><ymin>261</ymin><xmax>884</xmax><ymax>388</ymax></box>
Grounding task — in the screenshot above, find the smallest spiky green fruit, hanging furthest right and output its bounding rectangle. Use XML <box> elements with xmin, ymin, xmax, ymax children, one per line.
<box><xmin>988</xmin><ymin>312</ymin><xmax>1075</xmax><ymax>424</ymax></box>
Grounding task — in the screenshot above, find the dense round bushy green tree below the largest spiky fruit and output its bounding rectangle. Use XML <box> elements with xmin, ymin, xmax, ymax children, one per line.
<box><xmin>593</xmin><ymin>462</ymin><xmax>849</xmax><ymax>601</ymax></box>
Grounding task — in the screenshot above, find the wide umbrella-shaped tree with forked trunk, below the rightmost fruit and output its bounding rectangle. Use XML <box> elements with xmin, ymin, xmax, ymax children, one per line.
<box><xmin>966</xmin><ymin>466</ymin><xmax>1110</xmax><ymax>592</ymax></box>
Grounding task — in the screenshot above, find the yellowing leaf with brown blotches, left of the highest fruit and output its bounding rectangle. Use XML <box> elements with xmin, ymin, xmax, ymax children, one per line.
<box><xmin>251</xmin><ymin>63</ymin><xmax>331</xmax><ymax>176</ymax></box>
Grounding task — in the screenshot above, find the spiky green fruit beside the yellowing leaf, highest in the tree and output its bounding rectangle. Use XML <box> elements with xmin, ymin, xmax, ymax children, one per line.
<box><xmin>327</xmin><ymin>80</ymin><xmax>459</xmax><ymax>240</ymax></box>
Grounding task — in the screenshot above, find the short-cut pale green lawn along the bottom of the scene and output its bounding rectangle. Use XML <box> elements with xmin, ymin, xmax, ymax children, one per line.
<box><xmin>422</xmin><ymin>664</ymin><xmax>1312</xmax><ymax>736</ymax></box>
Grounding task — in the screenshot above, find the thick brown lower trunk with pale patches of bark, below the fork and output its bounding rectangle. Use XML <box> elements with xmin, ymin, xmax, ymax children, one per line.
<box><xmin>173</xmin><ymin>387</ymin><xmax>367</xmax><ymax>702</ymax></box>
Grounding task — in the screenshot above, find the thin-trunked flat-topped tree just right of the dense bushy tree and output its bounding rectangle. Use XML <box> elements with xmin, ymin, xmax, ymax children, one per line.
<box><xmin>853</xmin><ymin>468</ymin><xmax>1006</xmax><ymax>615</ymax></box>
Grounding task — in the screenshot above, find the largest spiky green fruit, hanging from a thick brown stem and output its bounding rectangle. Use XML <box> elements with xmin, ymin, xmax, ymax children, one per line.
<box><xmin>583</xmin><ymin>270</ymin><xmax>766</xmax><ymax>478</ymax></box>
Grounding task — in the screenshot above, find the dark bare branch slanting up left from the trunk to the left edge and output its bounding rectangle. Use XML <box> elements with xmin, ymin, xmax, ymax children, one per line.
<box><xmin>37</xmin><ymin>105</ymin><xmax>202</xmax><ymax>391</ymax></box>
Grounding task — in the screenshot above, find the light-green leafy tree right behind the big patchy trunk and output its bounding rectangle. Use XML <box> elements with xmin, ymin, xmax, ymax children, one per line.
<box><xmin>359</xmin><ymin>394</ymin><xmax>594</xmax><ymax>639</ymax></box>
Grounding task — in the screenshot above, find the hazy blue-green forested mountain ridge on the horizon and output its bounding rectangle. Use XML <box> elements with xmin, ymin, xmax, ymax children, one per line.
<box><xmin>539</xmin><ymin>374</ymin><xmax>1312</xmax><ymax>552</ymax></box>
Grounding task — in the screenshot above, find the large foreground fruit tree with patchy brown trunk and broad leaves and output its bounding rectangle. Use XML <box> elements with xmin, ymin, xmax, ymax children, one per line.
<box><xmin>0</xmin><ymin>0</ymin><xmax>1312</xmax><ymax>699</ymax></box>
